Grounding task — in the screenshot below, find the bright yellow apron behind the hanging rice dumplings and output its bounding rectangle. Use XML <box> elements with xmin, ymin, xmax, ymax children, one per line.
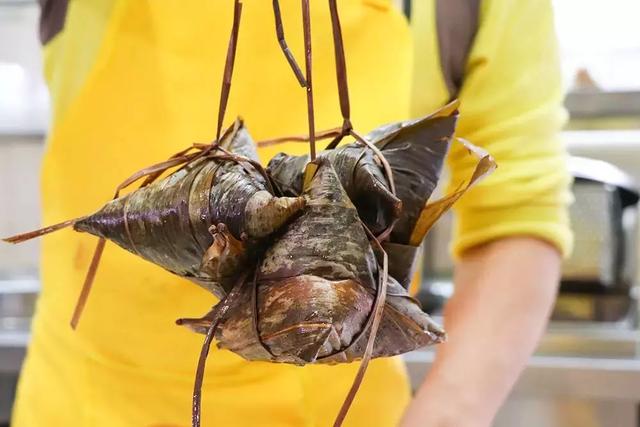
<box><xmin>12</xmin><ymin>0</ymin><xmax>418</xmax><ymax>427</ymax></box>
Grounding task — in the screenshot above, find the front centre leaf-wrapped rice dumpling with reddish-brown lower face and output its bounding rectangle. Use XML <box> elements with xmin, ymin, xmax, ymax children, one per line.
<box><xmin>183</xmin><ymin>160</ymin><xmax>444</xmax><ymax>364</ymax></box>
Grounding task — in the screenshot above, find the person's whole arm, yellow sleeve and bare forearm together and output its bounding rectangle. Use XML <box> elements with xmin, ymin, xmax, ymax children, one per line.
<box><xmin>403</xmin><ymin>0</ymin><xmax>572</xmax><ymax>427</ymax></box>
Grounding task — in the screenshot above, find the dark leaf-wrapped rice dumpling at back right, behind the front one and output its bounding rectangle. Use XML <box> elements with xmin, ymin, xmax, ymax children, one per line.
<box><xmin>267</xmin><ymin>101</ymin><xmax>459</xmax><ymax>244</ymax></box>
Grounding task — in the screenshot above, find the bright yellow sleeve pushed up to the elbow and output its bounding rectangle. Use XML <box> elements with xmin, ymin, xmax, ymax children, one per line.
<box><xmin>449</xmin><ymin>0</ymin><xmax>572</xmax><ymax>257</ymax></box>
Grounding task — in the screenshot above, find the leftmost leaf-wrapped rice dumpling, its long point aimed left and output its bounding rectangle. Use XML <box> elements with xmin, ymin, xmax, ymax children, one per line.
<box><xmin>10</xmin><ymin>120</ymin><xmax>304</xmax><ymax>300</ymax></box>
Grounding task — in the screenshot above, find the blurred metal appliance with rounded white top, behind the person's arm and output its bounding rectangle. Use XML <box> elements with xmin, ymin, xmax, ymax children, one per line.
<box><xmin>421</xmin><ymin>157</ymin><xmax>638</xmax><ymax>322</ymax></box>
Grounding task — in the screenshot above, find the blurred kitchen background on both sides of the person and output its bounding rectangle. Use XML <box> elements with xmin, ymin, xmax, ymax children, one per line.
<box><xmin>0</xmin><ymin>0</ymin><xmax>640</xmax><ymax>427</ymax></box>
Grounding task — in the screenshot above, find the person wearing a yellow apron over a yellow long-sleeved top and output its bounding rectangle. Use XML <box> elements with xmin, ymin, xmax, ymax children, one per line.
<box><xmin>12</xmin><ymin>0</ymin><xmax>571</xmax><ymax>427</ymax></box>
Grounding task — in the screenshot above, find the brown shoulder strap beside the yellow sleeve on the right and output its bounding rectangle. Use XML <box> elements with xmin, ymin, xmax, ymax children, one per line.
<box><xmin>436</xmin><ymin>0</ymin><xmax>481</xmax><ymax>98</ymax></box>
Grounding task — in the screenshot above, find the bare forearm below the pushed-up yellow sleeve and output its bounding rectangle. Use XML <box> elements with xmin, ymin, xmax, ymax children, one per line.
<box><xmin>402</xmin><ymin>237</ymin><xmax>560</xmax><ymax>427</ymax></box>
